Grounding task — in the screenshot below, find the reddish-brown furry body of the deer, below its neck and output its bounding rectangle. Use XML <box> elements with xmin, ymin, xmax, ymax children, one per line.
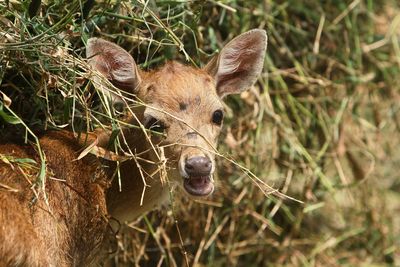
<box><xmin>0</xmin><ymin>132</ymin><xmax>108</xmax><ymax>266</ymax></box>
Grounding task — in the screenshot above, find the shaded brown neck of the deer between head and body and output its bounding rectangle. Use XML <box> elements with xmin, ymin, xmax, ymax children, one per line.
<box><xmin>107</xmin><ymin>113</ymin><xmax>170</xmax><ymax>222</ymax></box>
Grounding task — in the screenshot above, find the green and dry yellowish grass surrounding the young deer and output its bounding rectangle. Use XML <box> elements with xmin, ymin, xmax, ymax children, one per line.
<box><xmin>0</xmin><ymin>0</ymin><xmax>400</xmax><ymax>266</ymax></box>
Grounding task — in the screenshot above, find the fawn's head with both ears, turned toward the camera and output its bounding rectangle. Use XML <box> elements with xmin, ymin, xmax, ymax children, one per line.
<box><xmin>87</xmin><ymin>30</ymin><xmax>267</xmax><ymax>199</ymax></box>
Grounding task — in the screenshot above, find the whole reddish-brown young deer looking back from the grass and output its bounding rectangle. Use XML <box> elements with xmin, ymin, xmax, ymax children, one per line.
<box><xmin>0</xmin><ymin>29</ymin><xmax>267</xmax><ymax>266</ymax></box>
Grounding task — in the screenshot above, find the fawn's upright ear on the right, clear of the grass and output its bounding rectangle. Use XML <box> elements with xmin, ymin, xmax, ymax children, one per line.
<box><xmin>204</xmin><ymin>29</ymin><xmax>267</xmax><ymax>97</ymax></box>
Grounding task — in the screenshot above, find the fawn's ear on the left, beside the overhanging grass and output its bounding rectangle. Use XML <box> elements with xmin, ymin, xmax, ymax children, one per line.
<box><xmin>86</xmin><ymin>38</ymin><xmax>141</xmax><ymax>104</ymax></box>
